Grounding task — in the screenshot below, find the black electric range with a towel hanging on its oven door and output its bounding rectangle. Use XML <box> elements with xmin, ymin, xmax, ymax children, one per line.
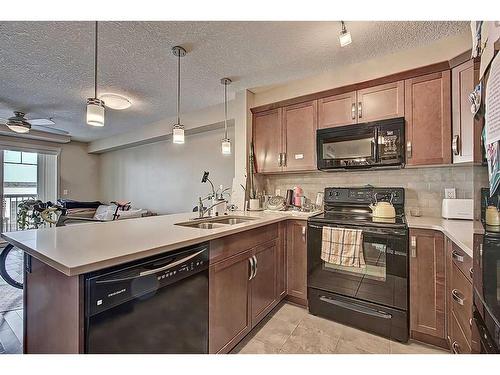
<box><xmin>307</xmin><ymin>187</ymin><xmax>409</xmax><ymax>342</ymax></box>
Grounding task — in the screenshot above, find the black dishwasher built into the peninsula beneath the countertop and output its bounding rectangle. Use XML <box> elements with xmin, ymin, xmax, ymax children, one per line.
<box><xmin>85</xmin><ymin>243</ymin><xmax>208</xmax><ymax>354</ymax></box>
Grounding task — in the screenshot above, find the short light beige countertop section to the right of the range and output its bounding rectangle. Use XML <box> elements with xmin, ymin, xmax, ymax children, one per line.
<box><xmin>406</xmin><ymin>215</ymin><xmax>474</xmax><ymax>258</ymax></box>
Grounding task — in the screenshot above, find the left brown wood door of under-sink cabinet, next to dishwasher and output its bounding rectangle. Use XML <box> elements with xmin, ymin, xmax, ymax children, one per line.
<box><xmin>208</xmin><ymin>250</ymin><xmax>252</xmax><ymax>353</ymax></box>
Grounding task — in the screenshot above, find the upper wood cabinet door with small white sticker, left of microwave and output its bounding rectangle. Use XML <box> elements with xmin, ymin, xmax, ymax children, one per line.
<box><xmin>283</xmin><ymin>100</ymin><xmax>318</xmax><ymax>172</ymax></box>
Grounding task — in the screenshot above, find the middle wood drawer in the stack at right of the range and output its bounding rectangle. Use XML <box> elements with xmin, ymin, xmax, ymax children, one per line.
<box><xmin>450</xmin><ymin>264</ymin><xmax>472</xmax><ymax>342</ymax></box>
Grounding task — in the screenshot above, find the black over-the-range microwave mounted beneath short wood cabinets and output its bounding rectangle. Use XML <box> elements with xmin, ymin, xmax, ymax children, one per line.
<box><xmin>316</xmin><ymin>117</ymin><xmax>405</xmax><ymax>170</ymax></box>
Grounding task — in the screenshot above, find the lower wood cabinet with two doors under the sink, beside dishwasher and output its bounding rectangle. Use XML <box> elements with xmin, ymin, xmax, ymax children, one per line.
<box><xmin>209</xmin><ymin>224</ymin><xmax>286</xmax><ymax>353</ymax></box>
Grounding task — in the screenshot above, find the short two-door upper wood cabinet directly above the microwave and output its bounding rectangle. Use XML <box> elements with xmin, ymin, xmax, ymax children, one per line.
<box><xmin>318</xmin><ymin>81</ymin><xmax>405</xmax><ymax>129</ymax></box>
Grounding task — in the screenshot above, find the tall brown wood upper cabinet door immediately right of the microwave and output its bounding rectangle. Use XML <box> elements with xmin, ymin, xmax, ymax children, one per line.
<box><xmin>405</xmin><ymin>71</ymin><xmax>451</xmax><ymax>165</ymax></box>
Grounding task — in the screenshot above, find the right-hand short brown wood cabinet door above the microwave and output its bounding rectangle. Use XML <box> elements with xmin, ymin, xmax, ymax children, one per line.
<box><xmin>357</xmin><ymin>81</ymin><xmax>405</xmax><ymax>123</ymax></box>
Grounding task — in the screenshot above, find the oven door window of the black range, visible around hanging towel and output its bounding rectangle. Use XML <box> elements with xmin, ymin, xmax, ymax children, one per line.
<box><xmin>323</xmin><ymin>241</ymin><xmax>387</xmax><ymax>281</ymax></box>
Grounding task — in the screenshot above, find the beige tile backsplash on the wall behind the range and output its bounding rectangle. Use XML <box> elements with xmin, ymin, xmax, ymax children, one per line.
<box><xmin>257</xmin><ymin>166</ymin><xmax>473</xmax><ymax>217</ymax></box>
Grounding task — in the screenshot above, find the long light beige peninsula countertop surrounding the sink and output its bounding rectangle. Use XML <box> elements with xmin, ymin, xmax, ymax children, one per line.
<box><xmin>2</xmin><ymin>211</ymin><xmax>317</xmax><ymax>276</ymax></box>
